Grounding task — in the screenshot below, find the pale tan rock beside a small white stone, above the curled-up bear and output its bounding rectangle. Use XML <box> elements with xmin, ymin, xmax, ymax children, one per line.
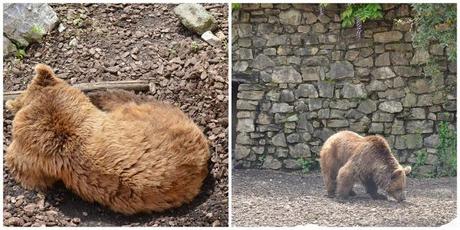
<box><xmin>174</xmin><ymin>3</ymin><xmax>217</xmax><ymax>35</ymax></box>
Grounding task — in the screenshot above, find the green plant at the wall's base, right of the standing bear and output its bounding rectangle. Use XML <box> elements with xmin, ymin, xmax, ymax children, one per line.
<box><xmin>435</xmin><ymin>121</ymin><xmax>457</xmax><ymax>176</ymax></box>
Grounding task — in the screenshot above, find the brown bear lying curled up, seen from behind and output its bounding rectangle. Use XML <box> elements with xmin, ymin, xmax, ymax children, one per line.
<box><xmin>5</xmin><ymin>64</ymin><xmax>210</xmax><ymax>214</ymax></box>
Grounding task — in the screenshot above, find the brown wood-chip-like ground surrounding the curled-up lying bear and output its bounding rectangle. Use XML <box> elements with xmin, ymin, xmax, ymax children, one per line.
<box><xmin>3</xmin><ymin>4</ymin><xmax>228</xmax><ymax>226</ymax></box>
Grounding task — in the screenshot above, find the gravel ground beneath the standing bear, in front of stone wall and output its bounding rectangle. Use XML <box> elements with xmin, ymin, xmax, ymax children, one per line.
<box><xmin>232</xmin><ymin>170</ymin><xmax>457</xmax><ymax>226</ymax></box>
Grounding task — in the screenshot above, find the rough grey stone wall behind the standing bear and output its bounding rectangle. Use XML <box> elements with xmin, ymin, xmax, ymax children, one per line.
<box><xmin>232</xmin><ymin>4</ymin><xmax>456</xmax><ymax>172</ymax></box>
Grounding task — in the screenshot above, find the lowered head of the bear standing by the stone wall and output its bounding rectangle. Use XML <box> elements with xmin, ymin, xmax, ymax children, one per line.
<box><xmin>387</xmin><ymin>166</ymin><xmax>412</xmax><ymax>202</ymax></box>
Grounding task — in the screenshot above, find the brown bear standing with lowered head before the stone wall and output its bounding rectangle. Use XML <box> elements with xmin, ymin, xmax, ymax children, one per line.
<box><xmin>320</xmin><ymin>131</ymin><xmax>411</xmax><ymax>201</ymax></box>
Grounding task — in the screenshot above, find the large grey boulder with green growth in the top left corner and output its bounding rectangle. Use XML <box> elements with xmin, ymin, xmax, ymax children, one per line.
<box><xmin>3</xmin><ymin>3</ymin><xmax>59</xmax><ymax>47</ymax></box>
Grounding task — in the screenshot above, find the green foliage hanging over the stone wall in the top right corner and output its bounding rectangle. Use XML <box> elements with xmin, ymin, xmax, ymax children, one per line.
<box><xmin>412</xmin><ymin>4</ymin><xmax>457</xmax><ymax>76</ymax></box>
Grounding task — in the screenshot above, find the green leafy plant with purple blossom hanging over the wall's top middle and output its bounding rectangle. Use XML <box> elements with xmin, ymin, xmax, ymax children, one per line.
<box><xmin>340</xmin><ymin>3</ymin><xmax>383</xmax><ymax>39</ymax></box>
